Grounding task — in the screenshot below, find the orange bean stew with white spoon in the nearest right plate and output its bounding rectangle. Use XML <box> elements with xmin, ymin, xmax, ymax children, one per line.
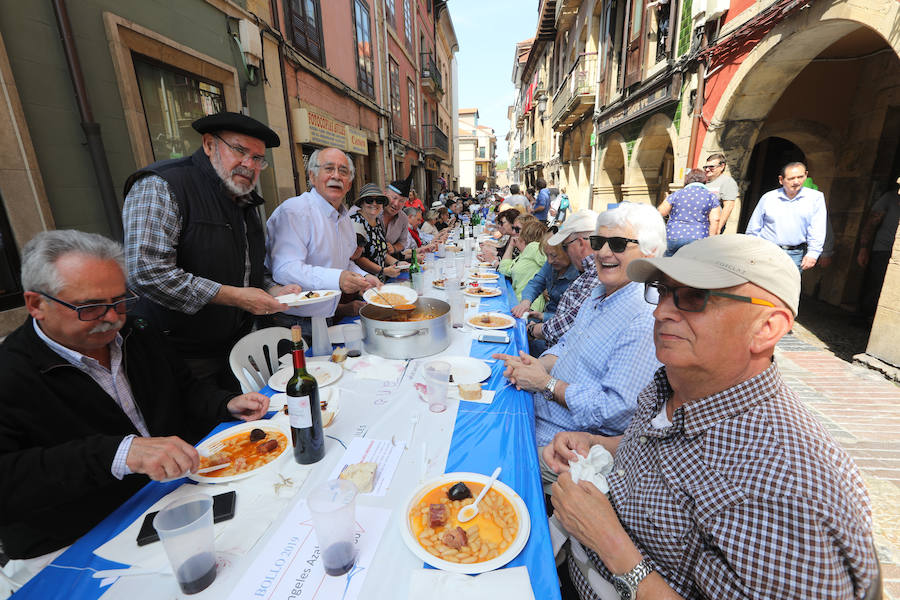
<box><xmin>409</xmin><ymin>481</ymin><xmax>519</xmax><ymax>564</ymax></box>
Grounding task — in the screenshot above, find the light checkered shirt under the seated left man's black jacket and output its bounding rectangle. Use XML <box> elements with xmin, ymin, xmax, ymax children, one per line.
<box><xmin>34</xmin><ymin>320</ymin><xmax>150</xmax><ymax>479</ymax></box>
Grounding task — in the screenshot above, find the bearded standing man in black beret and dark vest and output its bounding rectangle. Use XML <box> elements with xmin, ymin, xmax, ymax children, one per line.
<box><xmin>123</xmin><ymin>112</ymin><xmax>300</xmax><ymax>391</ymax></box>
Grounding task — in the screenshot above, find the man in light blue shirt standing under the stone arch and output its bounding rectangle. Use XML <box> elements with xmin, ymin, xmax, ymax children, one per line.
<box><xmin>746</xmin><ymin>162</ymin><xmax>827</xmax><ymax>271</ymax></box>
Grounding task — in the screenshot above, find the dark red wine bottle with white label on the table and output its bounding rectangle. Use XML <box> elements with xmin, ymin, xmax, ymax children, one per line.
<box><xmin>284</xmin><ymin>325</ymin><xmax>325</xmax><ymax>465</ymax></box>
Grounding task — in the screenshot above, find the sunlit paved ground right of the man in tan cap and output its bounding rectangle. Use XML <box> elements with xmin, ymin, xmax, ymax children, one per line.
<box><xmin>775</xmin><ymin>324</ymin><xmax>900</xmax><ymax>600</ymax></box>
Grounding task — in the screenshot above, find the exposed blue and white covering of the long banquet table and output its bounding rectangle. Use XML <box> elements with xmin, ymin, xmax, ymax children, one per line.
<box><xmin>13</xmin><ymin>262</ymin><xmax>560</xmax><ymax>600</ymax></box>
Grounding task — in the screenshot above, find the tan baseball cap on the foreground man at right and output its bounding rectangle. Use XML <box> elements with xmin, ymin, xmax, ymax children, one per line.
<box><xmin>628</xmin><ymin>234</ymin><xmax>800</xmax><ymax>317</ymax></box>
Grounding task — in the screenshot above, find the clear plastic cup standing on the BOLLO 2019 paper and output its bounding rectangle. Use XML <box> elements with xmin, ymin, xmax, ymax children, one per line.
<box><xmin>306</xmin><ymin>479</ymin><xmax>359</xmax><ymax>577</ymax></box>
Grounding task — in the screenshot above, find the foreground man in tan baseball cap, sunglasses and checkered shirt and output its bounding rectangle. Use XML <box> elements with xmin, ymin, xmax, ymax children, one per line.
<box><xmin>543</xmin><ymin>235</ymin><xmax>879</xmax><ymax>600</ymax></box>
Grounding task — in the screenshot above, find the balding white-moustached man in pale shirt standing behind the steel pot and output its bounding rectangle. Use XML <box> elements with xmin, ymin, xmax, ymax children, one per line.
<box><xmin>266</xmin><ymin>148</ymin><xmax>379</xmax><ymax>316</ymax></box>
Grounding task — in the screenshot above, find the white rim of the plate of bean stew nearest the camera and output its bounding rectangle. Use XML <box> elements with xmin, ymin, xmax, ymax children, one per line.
<box><xmin>400</xmin><ymin>472</ymin><xmax>531</xmax><ymax>575</ymax></box>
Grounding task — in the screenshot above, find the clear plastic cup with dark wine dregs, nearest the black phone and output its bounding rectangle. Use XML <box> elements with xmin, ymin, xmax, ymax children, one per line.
<box><xmin>153</xmin><ymin>494</ymin><xmax>216</xmax><ymax>594</ymax></box>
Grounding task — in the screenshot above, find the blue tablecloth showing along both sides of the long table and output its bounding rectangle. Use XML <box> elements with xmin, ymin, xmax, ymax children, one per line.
<box><xmin>13</xmin><ymin>281</ymin><xmax>560</xmax><ymax>600</ymax></box>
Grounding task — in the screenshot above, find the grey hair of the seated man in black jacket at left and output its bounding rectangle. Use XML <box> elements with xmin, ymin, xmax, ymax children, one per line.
<box><xmin>22</xmin><ymin>229</ymin><xmax>125</xmax><ymax>296</ymax></box>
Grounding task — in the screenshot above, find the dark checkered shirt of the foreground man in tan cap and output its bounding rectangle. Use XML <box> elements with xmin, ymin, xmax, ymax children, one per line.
<box><xmin>569</xmin><ymin>364</ymin><xmax>876</xmax><ymax>600</ymax></box>
